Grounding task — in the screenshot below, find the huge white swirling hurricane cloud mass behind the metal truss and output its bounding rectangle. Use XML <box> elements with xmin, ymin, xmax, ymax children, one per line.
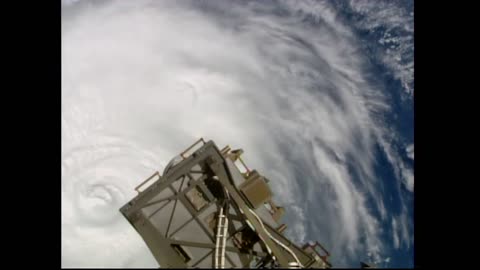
<box><xmin>62</xmin><ymin>1</ymin><xmax>413</xmax><ymax>267</ymax></box>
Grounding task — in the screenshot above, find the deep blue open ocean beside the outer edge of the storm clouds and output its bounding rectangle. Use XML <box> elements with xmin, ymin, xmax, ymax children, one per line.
<box><xmin>332</xmin><ymin>1</ymin><xmax>414</xmax><ymax>268</ymax></box>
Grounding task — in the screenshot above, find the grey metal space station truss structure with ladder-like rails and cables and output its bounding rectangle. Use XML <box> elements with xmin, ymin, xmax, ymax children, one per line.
<box><xmin>120</xmin><ymin>139</ymin><xmax>331</xmax><ymax>268</ymax></box>
